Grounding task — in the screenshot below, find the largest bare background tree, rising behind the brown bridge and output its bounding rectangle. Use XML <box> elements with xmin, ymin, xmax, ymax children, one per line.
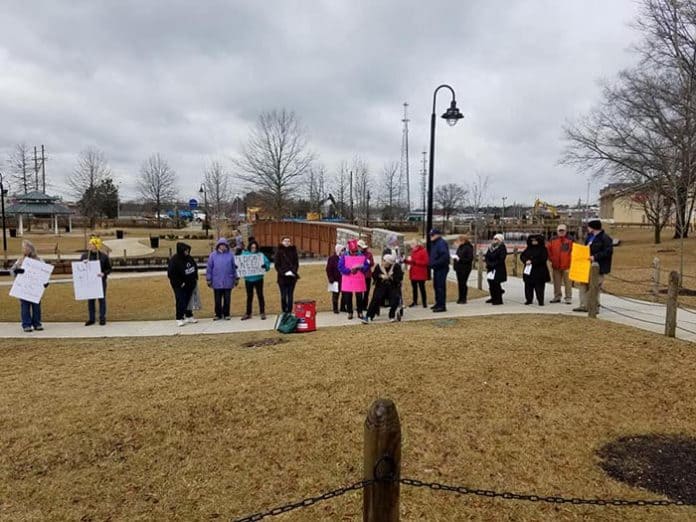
<box><xmin>235</xmin><ymin>109</ymin><xmax>314</xmax><ymax>217</ymax></box>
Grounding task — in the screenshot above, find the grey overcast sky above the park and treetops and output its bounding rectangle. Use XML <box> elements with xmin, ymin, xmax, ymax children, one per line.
<box><xmin>0</xmin><ymin>0</ymin><xmax>639</xmax><ymax>205</ymax></box>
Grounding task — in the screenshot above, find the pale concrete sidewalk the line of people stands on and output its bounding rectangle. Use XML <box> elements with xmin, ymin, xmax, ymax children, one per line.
<box><xmin>0</xmin><ymin>278</ymin><xmax>696</xmax><ymax>342</ymax></box>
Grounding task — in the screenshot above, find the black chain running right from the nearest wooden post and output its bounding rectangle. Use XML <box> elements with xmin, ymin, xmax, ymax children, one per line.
<box><xmin>399</xmin><ymin>478</ymin><xmax>694</xmax><ymax>506</ymax></box>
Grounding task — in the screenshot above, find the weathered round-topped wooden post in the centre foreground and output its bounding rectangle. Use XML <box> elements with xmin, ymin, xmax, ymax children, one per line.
<box><xmin>363</xmin><ymin>399</ymin><xmax>401</xmax><ymax>522</ymax></box>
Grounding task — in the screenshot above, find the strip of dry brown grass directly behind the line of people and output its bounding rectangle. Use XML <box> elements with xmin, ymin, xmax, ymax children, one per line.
<box><xmin>0</xmin><ymin>264</ymin><xmax>474</xmax><ymax>322</ymax></box>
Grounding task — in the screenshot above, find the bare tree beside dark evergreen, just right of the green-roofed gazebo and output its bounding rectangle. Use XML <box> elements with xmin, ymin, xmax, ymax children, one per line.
<box><xmin>68</xmin><ymin>147</ymin><xmax>111</xmax><ymax>228</ymax></box>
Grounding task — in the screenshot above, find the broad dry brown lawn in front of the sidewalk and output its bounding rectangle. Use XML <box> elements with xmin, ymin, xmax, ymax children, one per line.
<box><xmin>0</xmin><ymin>316</ymin><xmax>696</xmax><ymax>521</ymax></box>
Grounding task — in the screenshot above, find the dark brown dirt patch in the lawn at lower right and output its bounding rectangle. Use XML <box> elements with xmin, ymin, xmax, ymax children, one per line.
<box><xmin>597</xmin><ymin>434</ymin><xmax>696</xmax><ymax>504</ymax></box>
